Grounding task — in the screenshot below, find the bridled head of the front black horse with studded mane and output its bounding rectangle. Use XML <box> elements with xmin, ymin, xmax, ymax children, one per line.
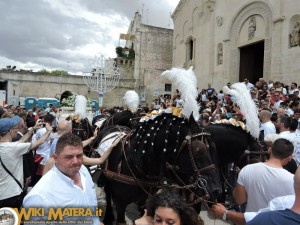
<box><xmin>173</xmin><ymin>115</ymin><xmax>222</xmax><ymax>202</ymax></box>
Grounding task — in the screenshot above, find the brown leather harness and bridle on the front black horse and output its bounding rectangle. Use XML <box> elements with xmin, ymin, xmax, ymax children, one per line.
<box><xmin>103</xmin><ymin>127</ymin><xmax>216</xmax><ymax>205</ymax></box>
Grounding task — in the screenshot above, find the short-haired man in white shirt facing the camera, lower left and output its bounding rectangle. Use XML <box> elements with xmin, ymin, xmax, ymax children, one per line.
<box><xmin>23</xmin><ymin>134</ymin><xmax>100</xmax><ymax>224</ymax></box>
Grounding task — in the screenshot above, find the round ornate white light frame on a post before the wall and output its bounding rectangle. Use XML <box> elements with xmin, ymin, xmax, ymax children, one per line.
<box><xmin>83</xmin><ymin>55</ymin><xmax>120</xmax><ymax>107</ymax></box>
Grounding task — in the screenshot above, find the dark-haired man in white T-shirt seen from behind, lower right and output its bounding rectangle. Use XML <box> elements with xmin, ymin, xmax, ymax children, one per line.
<box><xmin>233</xmin><ymin>138</ymin><xmax>294</xmax><ymax>212</ymax></box>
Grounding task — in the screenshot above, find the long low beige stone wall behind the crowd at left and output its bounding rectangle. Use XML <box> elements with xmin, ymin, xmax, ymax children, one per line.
<box><xmin>0</xmin><ymin>62</ymin><xmax>135</xmax><ymax>107</ymax></box>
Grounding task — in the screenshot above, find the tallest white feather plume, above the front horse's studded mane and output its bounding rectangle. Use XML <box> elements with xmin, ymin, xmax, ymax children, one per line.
<box><xmin>161</xmin><ymin>66</ymin><xmax>200</xmax><ymax>121</ymax></box>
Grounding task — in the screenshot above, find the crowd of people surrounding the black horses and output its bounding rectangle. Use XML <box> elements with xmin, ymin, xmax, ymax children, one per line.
<box><xmin>0</xmin><ymin>78</ymin><xmax>300</xmax><ymax>224</ymax></box>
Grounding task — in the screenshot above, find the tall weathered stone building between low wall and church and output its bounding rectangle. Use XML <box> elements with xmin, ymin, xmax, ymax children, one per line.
<box><xmin>122</xmin><ymin>12</ymin><xmax>173</xmax><ymax>105</ymax></box>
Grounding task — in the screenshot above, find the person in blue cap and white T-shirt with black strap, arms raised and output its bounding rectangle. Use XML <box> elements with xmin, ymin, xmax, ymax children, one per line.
<box><xmin>0</xmin><ymin>116</ymin><xmax>52</xmax><ymax>208</ymax></box>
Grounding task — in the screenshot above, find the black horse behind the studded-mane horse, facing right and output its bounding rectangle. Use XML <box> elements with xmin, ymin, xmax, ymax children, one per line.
<box><xmin>205</xmin><ymin>124</ymin><xmax>266</xmax><ymax>204</ymax></box>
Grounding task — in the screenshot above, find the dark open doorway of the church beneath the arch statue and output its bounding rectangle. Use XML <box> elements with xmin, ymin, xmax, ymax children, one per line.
<box><xmin>239</xmin><ymin>41</ymin><xmax>265</xmax><ymax>84</ymax></box>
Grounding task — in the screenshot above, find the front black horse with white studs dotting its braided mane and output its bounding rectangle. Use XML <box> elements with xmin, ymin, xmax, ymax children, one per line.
<box><xmin>100</xmin><ymin>114</ymin><xmax>221</xmax><ymax>224</ymax></box>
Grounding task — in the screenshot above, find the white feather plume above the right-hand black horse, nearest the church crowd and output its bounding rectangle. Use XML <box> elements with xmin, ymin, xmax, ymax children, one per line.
<box><xmin>223</xmin><ymin>83</ymin><xmax>259</xmax><ymax>138</ymax></box>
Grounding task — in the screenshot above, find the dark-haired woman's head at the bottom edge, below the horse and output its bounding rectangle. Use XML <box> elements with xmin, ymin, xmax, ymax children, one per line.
<box><xmin>133</xmin><ymin>189</ymin><xmax>204</xmax><ymax>225</ymax></box>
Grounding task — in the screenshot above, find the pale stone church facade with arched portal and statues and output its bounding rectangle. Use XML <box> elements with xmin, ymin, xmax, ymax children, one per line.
<box><xmin>172</xmin><ymin>0</ymin><xmax>300</xmax><ymax>89</ymax></box>
